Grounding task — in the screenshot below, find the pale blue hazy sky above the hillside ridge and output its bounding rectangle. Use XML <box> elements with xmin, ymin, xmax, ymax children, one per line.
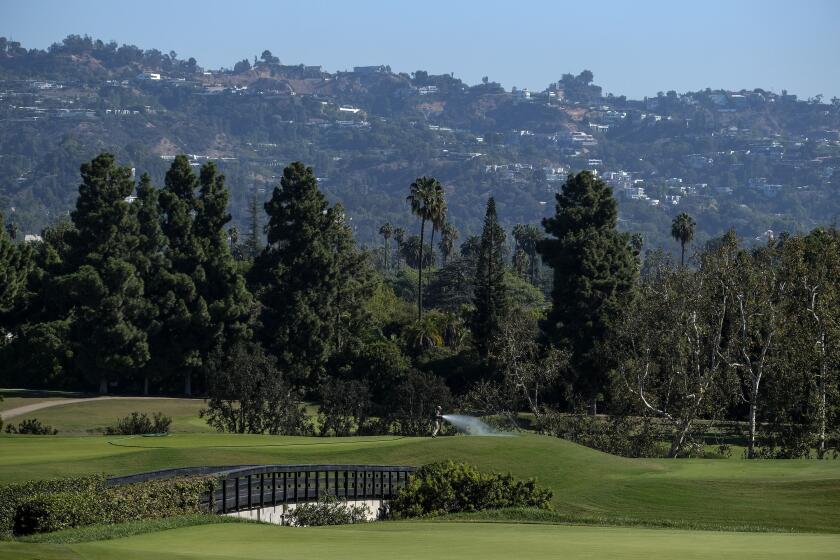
<box><xmin>0</xmin><ymin>0</ymin><xmax>840</xmax><ymax>98</ymax></box>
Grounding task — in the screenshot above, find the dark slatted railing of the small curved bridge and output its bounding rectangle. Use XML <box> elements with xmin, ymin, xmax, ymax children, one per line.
<box><xmin>205</xmin><ymin>465</ymin><xmax>415</xmax><ymax>513</ymax></box>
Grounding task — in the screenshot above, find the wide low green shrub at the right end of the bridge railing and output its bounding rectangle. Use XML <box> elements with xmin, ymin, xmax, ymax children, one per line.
<box><xmin>391</xmin><ymin>461</ymin><xmax>553</xmax><ymax>518</ymax></box>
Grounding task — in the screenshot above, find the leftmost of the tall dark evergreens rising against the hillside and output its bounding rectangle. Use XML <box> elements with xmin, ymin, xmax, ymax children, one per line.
<box><xmin>59</xmin><ymin>153</ymin><xmax>149</xmax><ymax>393</ymax></box>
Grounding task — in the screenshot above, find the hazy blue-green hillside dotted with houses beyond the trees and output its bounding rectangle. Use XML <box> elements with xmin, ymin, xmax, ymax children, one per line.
<box><xmin>0</xmin><ymin>36</ymin><xmax>840</xmax><ymax>252</ymax></box>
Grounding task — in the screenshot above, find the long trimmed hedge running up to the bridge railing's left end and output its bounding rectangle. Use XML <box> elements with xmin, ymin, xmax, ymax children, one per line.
<box><xmin>13</xmin><ymin>477</ymin><xmax>215</xmax><ymax>535</ymax></box>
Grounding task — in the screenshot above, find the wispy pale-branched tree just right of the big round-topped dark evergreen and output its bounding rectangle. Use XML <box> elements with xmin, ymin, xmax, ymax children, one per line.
<box><xmin>603</xmin><ymin>234</ymin><xmax>739</xmax><ymax>457</ymax></box>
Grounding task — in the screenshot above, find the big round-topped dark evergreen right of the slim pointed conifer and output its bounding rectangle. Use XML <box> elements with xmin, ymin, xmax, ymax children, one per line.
<box><xmin>538</xmin><ymin>171</ymin><xmax>638</xmax><ymax>411</ymax></box>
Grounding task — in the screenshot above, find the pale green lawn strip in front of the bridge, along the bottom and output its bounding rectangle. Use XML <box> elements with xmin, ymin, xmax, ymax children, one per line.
<box><xmin>0</xmin><ymin>522</ymin><xmax>840</xmax><ymax>560</ymax></box>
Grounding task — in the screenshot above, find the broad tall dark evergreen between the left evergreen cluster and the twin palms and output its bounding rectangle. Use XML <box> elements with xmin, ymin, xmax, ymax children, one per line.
<box><xmin>251</xmin><ymin>162</ymin><xmax>345</xmax><ymax>383</ymax></box>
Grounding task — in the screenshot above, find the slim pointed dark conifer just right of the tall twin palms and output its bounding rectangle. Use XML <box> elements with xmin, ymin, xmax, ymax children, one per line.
<box><xmin>472</xmin><ymin>196</ymin><xmax>508</xmax><ymax>356</ymax></box>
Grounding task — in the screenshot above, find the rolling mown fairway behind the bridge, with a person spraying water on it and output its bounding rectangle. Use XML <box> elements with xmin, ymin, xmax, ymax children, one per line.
<box><xmin>0</xmin><ymin>434</ymin><xmax>840</xmax><ymax>533</ymax></box>
